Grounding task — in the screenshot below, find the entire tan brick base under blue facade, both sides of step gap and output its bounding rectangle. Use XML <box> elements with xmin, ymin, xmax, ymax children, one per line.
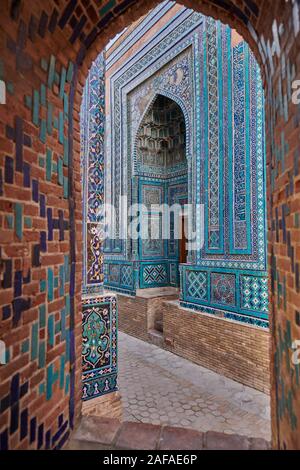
<box><xmin>118</xmin><ymin>295</ymin><xmax>270</xmax><ymax>393</ymax></box>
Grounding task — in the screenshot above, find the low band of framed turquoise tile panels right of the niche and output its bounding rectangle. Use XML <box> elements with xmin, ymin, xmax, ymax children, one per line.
<box><xmin>180</xmin><ymin>265</ymin><xmax>269</xmax><ymax>328</ymax></box>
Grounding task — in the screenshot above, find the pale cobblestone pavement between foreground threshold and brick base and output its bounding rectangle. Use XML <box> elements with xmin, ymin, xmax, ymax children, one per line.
<box><xmin>119</xmin><ymin>332</ymin><xmax>271</xmax><ymax>441</ymax></box>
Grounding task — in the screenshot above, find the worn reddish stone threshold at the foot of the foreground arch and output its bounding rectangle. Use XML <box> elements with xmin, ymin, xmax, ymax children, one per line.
<box><xmin>65</xmin><ymin>416</ymin><xmax>270</xmax><ymax>450</ymax></box>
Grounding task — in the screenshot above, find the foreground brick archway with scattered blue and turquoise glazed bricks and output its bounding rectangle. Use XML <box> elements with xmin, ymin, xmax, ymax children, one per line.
<box><xmin>0</xmin><ymin>0</ymin><xmax>300</xmax><ymax>448</ymax></box>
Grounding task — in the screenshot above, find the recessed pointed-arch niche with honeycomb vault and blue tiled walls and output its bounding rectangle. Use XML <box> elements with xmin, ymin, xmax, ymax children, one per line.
<box><xmin>135</xmin><ymin>95</ymin><xmax>188</xmax><ymax>288</ymax></box>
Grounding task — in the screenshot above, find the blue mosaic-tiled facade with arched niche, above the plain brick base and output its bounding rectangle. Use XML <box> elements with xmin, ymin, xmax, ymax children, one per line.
<box><xmin>104</xmin><ymin>10</ymin><xmax>268</xmax><ymax>327</ymax></box>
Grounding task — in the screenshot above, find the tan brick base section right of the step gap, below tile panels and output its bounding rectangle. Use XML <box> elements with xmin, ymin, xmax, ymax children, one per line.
<box><xmin>163</xmin><ymin>302</ymin><xmax>270</xmax><ymax>393</ymax></box>
